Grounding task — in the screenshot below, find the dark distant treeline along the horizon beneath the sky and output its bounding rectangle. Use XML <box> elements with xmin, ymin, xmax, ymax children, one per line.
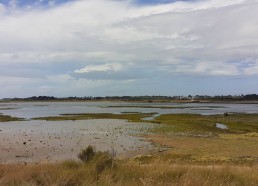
<box><xmin>1</xmin><ymin>94</ymin><xmax>258</xmax><ymax>102</ymax></box>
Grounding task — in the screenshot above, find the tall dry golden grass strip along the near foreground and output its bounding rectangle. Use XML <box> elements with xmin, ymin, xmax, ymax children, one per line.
<box><xmin>0</xmin><ymin>160</ymin><xmax>258</xmax><ymax>186</ymax></box>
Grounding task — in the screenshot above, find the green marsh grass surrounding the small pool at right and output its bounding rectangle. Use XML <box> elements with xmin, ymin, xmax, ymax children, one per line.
<box><xmin>152</xmin><ymin>114</ymin><xmax>258</xmax><ymax>135</ymax></box>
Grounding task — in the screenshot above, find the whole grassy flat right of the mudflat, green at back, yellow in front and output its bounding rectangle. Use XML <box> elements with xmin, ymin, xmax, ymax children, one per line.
<box><xmin>141</xmin><ymin>114</ymin><xmax>258</xmax><ymax>164</ymax></box>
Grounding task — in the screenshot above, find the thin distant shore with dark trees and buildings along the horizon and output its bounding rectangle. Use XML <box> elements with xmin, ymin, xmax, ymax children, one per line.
<box><xmin>0</xmin><ymin>94</ymin><xmax>258</xmax><ymax>104</ymax></box>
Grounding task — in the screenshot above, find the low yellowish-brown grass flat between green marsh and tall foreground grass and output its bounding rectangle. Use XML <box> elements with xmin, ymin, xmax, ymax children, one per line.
<box><xmin>146</xmin><ymin>133</ymin><xmax>258</xmax><ymax>163</ymax></box>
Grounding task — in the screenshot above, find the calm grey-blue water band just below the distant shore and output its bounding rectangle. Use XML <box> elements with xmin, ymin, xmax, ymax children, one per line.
<box><xmin>0</xmin><ymin>102</ymin><xmax>258</xmax><ymax>119</ymax></box>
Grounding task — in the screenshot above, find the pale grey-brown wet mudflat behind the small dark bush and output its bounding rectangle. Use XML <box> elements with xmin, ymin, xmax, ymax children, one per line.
<box><xmin>0</xmin><ymin>119</ymin><xmax>152</xmax><ymax>164</ymax></box>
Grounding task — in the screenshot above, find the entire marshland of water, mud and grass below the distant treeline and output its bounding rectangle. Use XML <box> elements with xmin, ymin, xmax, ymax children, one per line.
<box><xmin>0</xmin><ymin>102</ymin><xmax>258</xmax><ymax>185</ymax></box>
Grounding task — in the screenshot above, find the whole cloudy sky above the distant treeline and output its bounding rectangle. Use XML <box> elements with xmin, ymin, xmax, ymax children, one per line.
<box><xmin>0</xmin><ymin>0</ymin><xmax>258</xmax><ymax>98</ymax></box>
